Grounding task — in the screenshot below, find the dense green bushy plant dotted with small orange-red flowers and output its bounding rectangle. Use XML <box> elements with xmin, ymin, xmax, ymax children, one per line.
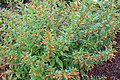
<box><xmin>0</xmin><ymin>0</ymin><xmax>120</xmax><ymax>80</ymax></box>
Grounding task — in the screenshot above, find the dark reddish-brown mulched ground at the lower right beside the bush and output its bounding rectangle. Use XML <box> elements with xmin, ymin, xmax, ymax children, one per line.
<box><xmin>88</xmin><ymin>33</ymin><xmax>120</xmax><ymax>80</ymax></box>
